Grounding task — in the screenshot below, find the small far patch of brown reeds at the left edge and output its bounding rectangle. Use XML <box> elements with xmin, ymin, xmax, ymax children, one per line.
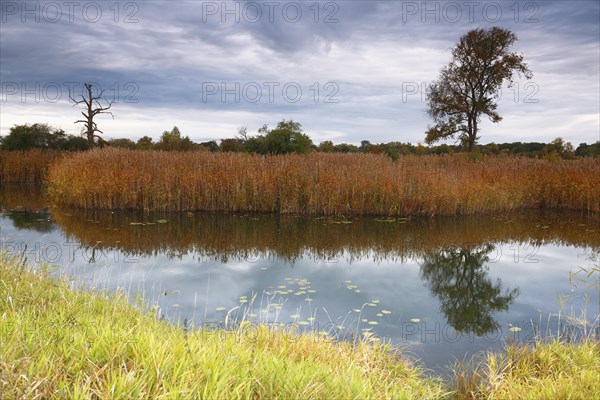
<box><xmin>0</xmin><ymin>150</ymin><xmax>63</xmax><ymax>184</ymax></box>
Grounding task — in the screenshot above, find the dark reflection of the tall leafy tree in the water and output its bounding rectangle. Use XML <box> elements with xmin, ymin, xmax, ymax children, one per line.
<box><xmin>421</xmin><ymin>244</ymin><xmax>519</xmax><ymax>336</ymax></box>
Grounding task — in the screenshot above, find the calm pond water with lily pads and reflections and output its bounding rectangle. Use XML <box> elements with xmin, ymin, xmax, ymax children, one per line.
<box><xmin>0</xmin><ymin>186</ymin><xmax>600</xmax><ymax>371</ymax></box>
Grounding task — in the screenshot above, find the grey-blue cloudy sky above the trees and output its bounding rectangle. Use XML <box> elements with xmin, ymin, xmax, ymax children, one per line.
<box><xmin>0</xmin><ymin>0</ymin><xmax>600</xmax><ymax>144</ymax></box>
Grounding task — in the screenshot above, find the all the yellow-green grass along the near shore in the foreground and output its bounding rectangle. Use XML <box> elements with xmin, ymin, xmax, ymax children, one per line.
<box><xmin>0</xmin><ymin>253</ymin><xmax>600</xmax><ymax>400</ymax></box>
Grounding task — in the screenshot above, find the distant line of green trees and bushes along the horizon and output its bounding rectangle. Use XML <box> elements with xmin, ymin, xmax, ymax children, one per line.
<box><xmin>0</xmin><ymin>120</ymin><xmax>600</xmax><ymax>160</ymax></box>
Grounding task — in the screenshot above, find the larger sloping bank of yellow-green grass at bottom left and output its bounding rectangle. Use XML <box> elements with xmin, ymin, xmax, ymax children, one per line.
<box><xmin>0</xmin><ymin>255</ymin><xmax>443</xmax><ymax>400</ymax></box>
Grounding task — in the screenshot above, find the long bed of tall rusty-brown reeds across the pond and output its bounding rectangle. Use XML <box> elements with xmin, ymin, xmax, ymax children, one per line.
<box><xmin>48</xmin><ymin>149</ymin><xmax>600</xmax><ymax>216</ymax></box>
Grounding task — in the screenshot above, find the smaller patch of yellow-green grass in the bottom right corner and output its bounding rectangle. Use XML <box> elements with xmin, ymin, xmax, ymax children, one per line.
<box><xmin>453</xmin><ymin>338</ymin><xmax>600</xmax><ymax>400</ymax></box>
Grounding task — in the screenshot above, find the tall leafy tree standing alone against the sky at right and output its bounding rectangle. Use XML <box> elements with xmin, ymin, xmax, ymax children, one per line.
<box><xmin>425</xmin><ymin>27</ymin><xmax>533</xmax><ymax>151</ymax></box>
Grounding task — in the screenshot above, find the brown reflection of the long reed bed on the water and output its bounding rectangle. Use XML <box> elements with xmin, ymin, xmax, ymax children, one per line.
<box><xmin>52</xmin><ymin>210</ymin><xmax>600</xmax><ymax>263</ymax></box>
